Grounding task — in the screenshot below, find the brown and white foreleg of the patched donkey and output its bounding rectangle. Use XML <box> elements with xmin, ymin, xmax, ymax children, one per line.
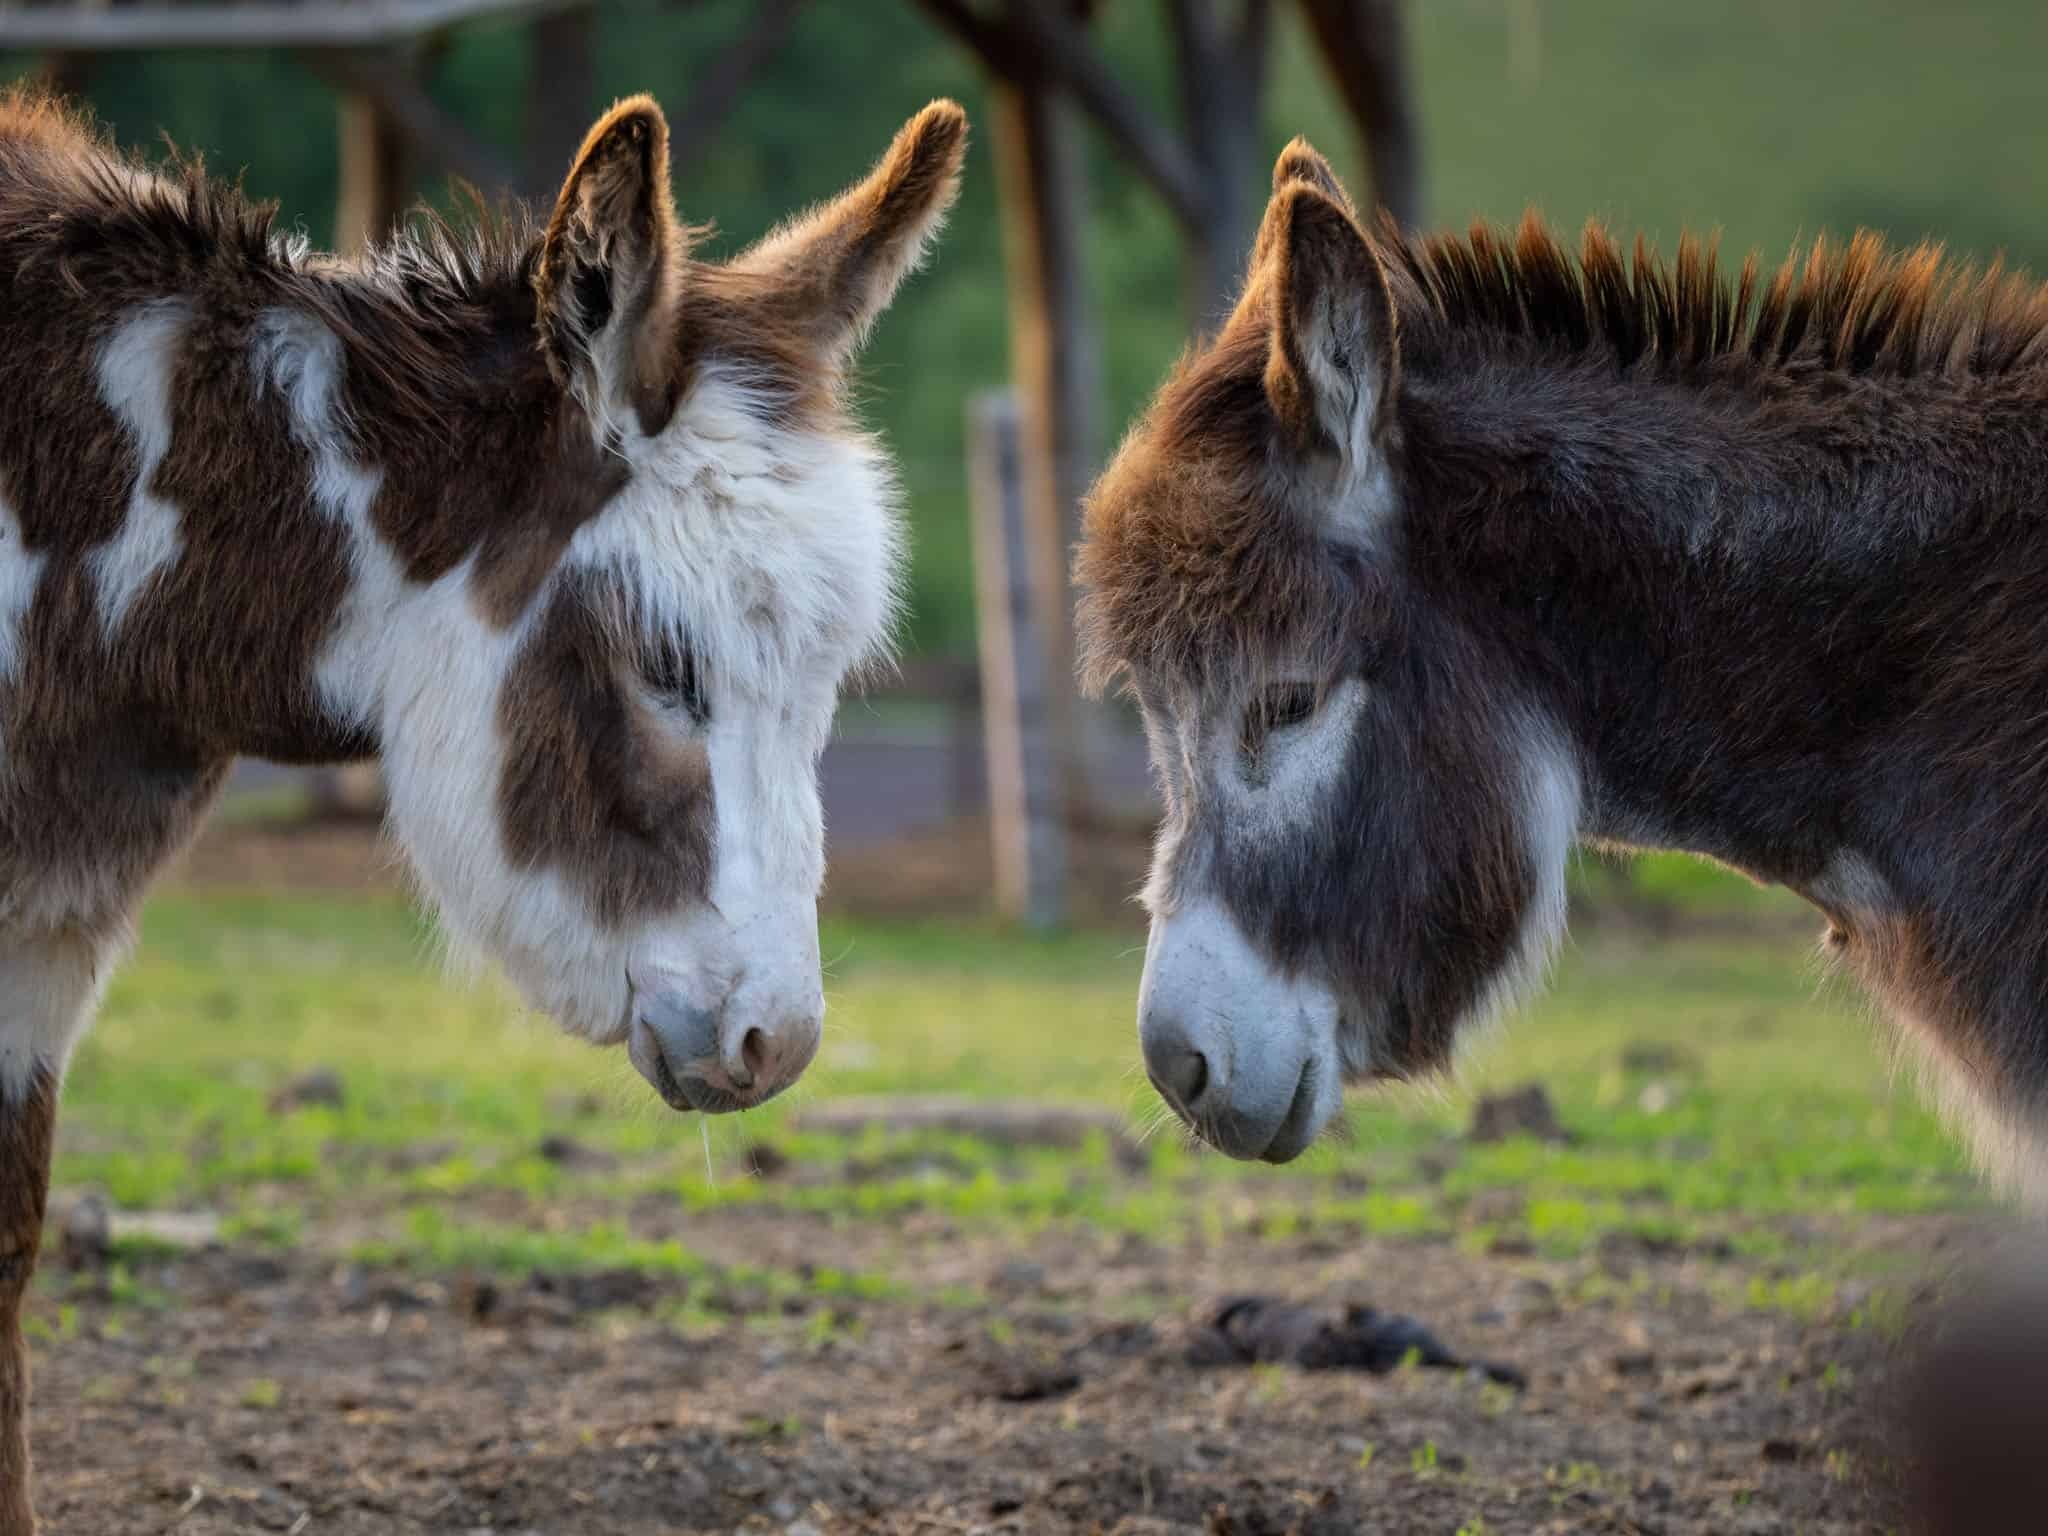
<box><xmin>0</xmin><ymin>934</ymin><xmax>100</xmax><ymax>1536</ymax></box>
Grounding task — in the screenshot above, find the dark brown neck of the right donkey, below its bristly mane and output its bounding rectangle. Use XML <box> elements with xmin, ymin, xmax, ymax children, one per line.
<box><xmin>1403</xmin><ymin>346</ymin><xmax>2048</xmax><ymax>891</ymax></box>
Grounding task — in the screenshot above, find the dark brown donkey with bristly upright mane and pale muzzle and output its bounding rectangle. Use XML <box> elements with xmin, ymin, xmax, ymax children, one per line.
<box><xmin>1079</xmin><ymin>143</ymin><xmax>2048</xmax><ymax>1190</ymax></box>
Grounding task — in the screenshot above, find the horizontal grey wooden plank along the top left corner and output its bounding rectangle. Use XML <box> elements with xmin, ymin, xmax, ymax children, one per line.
<box><xmin>0</xmin><ymin>0</ymin><xmax>592</xmax><ymax>53</ymax></box>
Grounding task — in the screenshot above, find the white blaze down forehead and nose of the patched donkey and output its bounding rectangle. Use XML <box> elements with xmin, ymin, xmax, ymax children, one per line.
<box><xmin>565</xmin><ymin>371</ymin><xmax>903</xmax><ymax>1028</ymax></box>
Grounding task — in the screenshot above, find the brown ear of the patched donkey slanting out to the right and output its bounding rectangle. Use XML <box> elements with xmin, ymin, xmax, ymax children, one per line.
<box><xmin>733</xmin><ymin>100</ymin><xmax>967</xmax><ymax>367</ymax></box>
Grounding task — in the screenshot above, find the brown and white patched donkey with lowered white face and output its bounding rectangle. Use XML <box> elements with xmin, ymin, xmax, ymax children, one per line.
<box><xmin>0</xmin><ymin>94</ymin><xmax>967</xmax><ymax>1536</ymax></box>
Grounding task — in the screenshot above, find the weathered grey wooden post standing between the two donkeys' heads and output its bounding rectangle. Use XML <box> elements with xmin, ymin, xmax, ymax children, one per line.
<box><xmin>967</xmin><ymin>391</ymin><xmax>1067</xmax><ymax>928</ymax></box>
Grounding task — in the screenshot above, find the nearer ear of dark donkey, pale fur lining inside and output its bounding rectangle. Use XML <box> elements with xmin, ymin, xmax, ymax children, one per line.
<box><xmin>1260</xmin><ymin>184</ymin><xmax>1401</xmax><ymax>463</ymax></box>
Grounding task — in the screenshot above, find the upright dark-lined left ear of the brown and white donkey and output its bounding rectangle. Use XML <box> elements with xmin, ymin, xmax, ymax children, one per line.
<box><xmin>532</xmin><ymin>96</ymin><xmax>690</xmax><ymax>434</ymax></box>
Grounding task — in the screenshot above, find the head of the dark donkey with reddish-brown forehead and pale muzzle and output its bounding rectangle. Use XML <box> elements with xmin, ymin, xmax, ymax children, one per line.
<box><xmin>1077</xmin><ymin>141</ymin><xmax>1577</xmax><ymax>1161</ymax></box>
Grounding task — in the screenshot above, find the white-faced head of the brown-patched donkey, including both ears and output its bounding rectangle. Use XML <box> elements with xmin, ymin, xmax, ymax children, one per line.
<box><xmin>383</xmin><ymin>98</ymin><xmax>967</xmax><ymax>1110</ymax></box>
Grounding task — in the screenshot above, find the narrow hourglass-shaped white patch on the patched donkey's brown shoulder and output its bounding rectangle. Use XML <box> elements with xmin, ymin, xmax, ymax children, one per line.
<box><xmin>86</xmin><ymin>299</ymin><xmax>193</xmax><ymax>641</ymax></box>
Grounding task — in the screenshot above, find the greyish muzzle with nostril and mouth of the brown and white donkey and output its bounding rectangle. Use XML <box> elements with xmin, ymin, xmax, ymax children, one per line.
<box><xmin>627</xmin><ymin>995</ymin><xmax>823</xmax><ymax>1114</ymax></box>
